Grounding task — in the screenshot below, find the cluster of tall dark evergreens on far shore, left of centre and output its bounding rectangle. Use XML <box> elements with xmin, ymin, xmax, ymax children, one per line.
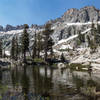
<box><xmin>10</xmin><ymin>24</ymin><xmax>54</xmax><ymax>62</ymax></box>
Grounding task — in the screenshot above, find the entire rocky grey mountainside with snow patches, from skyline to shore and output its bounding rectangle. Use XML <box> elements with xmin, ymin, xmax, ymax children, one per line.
<box><xmin>0</xmin><ymin>6</ymin><xmax>100</xmax><ymax>69</ymax></box>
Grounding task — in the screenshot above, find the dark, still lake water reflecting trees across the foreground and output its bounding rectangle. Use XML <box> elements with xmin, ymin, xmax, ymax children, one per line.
<box><xmin>0</xmin><ymin>66</ymin><xmax>100</xmax><ymax>100</ymax></box>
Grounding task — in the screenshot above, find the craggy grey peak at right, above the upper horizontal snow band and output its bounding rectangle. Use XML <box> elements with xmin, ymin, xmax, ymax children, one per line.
<box><xmin>62</xmin><ymin>6</ymin><xmax>100</xmax><ymax>22</ymax></box>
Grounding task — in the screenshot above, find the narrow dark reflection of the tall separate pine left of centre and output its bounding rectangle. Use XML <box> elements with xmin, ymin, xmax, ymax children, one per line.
<box><xmin>21</xmin><ymin>66</ymin><xmax>30</xmax><ymax>100</ymax></box>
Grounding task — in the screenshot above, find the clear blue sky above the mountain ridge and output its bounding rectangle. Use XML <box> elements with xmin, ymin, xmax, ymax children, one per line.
<box><xmin>0</xmin><ymin>0</ymin><xmax>100</xmax><ymax>26</ymax></box>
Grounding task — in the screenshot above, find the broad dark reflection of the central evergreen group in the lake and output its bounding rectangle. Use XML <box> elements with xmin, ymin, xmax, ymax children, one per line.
<box><xmin>33</xmin><ymin>67</ymin><xmax>53</xmax><ymax>96</ymax></box>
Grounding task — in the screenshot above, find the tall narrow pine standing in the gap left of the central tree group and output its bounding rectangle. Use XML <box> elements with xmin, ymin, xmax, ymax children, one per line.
<box><xmin>21</xmin><ymin>24</ymin><xmax>29</xmax><ymax>62</ymax></box>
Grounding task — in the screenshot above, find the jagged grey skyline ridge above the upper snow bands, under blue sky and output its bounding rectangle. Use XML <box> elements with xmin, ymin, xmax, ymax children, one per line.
<box><xmin>0</xmin><ymin>6</ymin><xmax>100</xmax><ymax>32</ymax></box>
